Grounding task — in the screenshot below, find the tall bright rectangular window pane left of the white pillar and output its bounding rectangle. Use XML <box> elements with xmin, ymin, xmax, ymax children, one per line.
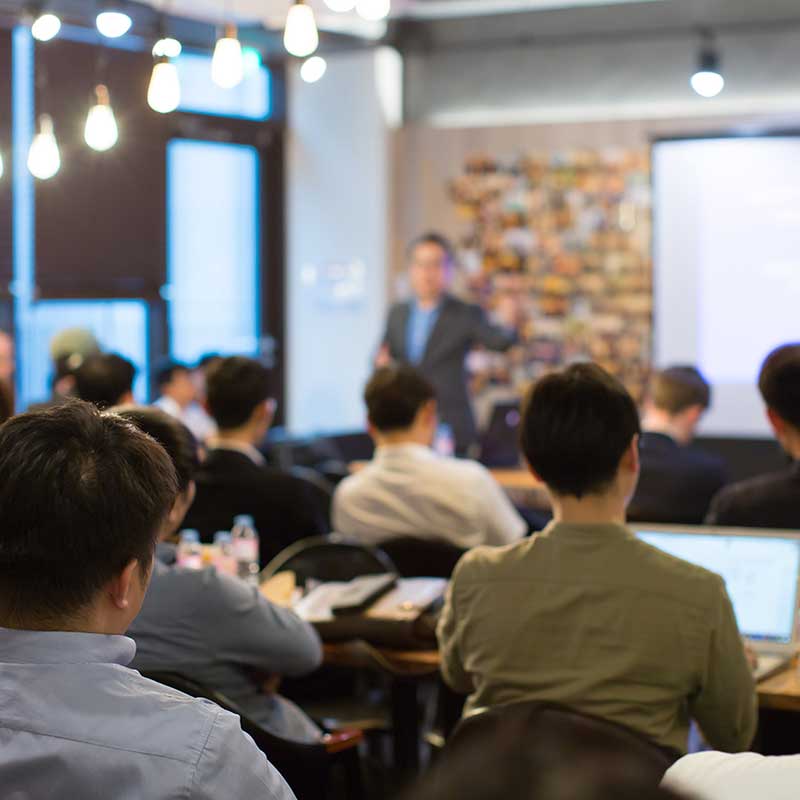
<box><xmin>167</xmin><ymin>139</ymin><xmax>260</xmax><ymax>362</ymax></box>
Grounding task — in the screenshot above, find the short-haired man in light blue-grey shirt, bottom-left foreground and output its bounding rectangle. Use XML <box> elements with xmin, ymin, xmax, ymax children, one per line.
<box><xmin>0</xmin><ymin>401</ymin><xmax>294</xmax><ymax>800</ymax></box>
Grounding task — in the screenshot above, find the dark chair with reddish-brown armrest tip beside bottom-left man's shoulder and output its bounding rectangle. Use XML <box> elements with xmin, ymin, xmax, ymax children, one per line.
<box><xmin>142</xmin><ymin>671</ymin><xmax>364</xmax><ymax>800</ymax></box>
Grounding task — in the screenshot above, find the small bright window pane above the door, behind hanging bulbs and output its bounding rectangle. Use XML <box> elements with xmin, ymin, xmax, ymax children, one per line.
<box><xmin>174</xmin><ymin>53</ymin><xmax>272</xmax><ymax>119</ymax></box>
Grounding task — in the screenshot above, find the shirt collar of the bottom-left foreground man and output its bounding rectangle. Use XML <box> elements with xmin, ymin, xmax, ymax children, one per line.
<box><xmin>0</xmin><ymin>628</ymin><xmax>136</xmax><ymax>667</ymax></box>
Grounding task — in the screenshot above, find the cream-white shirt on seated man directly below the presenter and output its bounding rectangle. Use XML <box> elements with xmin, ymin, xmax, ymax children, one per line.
<box><xmin>333</xmin><ymin>444</ymin><xmax>527</xmax><ymax>549</ymax></box>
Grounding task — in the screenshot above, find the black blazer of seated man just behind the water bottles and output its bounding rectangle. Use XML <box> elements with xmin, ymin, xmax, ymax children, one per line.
<box><xmin>181</xmin><ymin>449</ymin><xmax>330</xmax><ymax>567</ymax></box>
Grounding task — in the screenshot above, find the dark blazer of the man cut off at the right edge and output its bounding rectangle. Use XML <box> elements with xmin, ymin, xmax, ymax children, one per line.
<box><xmin>706</xmin><ymin>461</ymin><xmax>800</xmax><ymax>530</ymax></box>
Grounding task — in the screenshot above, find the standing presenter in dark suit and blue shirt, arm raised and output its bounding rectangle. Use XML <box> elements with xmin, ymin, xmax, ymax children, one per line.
<box><xmin>376</xmin><ymin>233</ymin><xmax>519</xmax><ymax>455</ymax></box>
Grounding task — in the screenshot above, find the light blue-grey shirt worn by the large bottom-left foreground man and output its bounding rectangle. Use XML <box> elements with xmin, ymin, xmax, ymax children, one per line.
<box><xmin>0</xmin><ymin>628</ymin><xmax>294</xmax><ymax>800</ymax></box>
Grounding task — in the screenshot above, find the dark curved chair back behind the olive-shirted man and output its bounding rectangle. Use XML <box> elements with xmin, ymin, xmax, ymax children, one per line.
<box><xmin>445</xmin><ymin>701</ymin><xmax>680</xmax><ymax>785</ymax></box>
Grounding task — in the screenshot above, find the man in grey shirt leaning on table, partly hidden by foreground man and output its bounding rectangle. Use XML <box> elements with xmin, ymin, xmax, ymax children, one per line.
<box><xmin>116</xmin><ymin>406</ymin><xmax>322</xmax><ymax>743</ymax></box>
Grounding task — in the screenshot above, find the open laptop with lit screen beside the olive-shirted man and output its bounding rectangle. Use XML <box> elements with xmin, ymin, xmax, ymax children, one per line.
<box><xmin>631</xmin><ymin>523</ymin><xmax>800</xmax><ymax>680</ymax></box>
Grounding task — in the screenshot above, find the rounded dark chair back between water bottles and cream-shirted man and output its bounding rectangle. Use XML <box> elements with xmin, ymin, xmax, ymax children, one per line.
<box><xmin>261</xmin><ymin>533</ymin><xmax>397</xmax><ymax>585</ymax></box>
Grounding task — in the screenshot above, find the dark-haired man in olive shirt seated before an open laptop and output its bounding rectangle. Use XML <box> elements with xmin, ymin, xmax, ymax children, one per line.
<box><xmin>438</xmin><ymin>364</ymin><xmax>757</xmax><ymax>753</ymax></box>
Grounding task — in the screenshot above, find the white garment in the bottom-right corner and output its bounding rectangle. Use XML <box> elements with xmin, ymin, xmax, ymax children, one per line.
<box><xmin>663</xmin><ymin>752</ymin><xmax>800</xmax><ymax>800</ymax></box>
